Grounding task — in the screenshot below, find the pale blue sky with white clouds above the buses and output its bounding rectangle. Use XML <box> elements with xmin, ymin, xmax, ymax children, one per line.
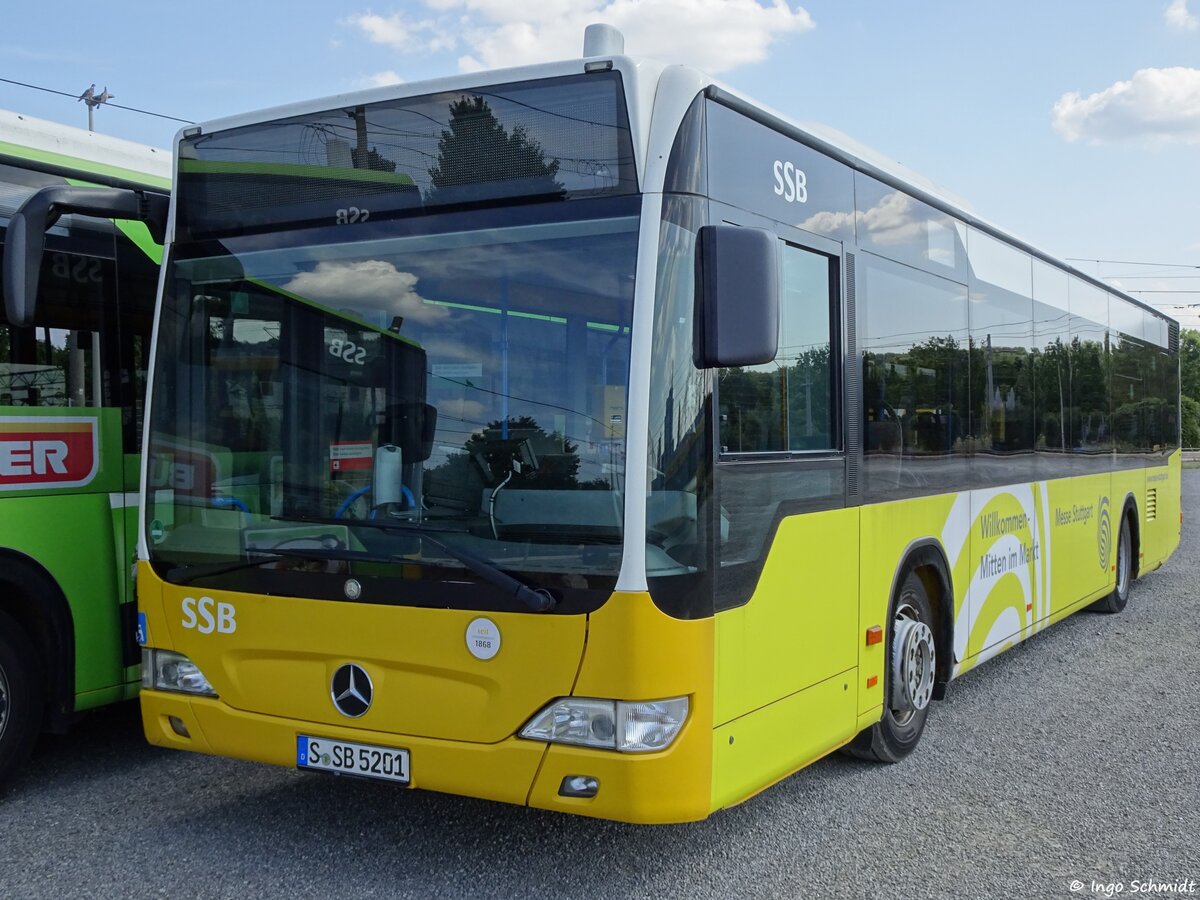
<box><xmin>0</xmin><ymin>0</ymin><xmax>1200</xmax><ymax>326</ymax></box>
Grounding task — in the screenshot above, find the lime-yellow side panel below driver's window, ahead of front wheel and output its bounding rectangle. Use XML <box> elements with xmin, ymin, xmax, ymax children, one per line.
<box><xmin>712</xmin><ymin>509</ymin><xmax>859</xmax><ymax>809</ymax></box>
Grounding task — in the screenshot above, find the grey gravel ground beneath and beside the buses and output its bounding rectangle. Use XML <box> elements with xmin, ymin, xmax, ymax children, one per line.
<box><xmin>0</xmin><ymin>470</ymin><xmax>1200</xmax><ymax>899</ymax></box>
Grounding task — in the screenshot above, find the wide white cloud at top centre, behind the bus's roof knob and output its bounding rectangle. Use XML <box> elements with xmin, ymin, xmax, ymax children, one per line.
<box><xmin>347</xmin><ymin>0</ymin><xmax>814</xmax><ymax>72</ymax></box>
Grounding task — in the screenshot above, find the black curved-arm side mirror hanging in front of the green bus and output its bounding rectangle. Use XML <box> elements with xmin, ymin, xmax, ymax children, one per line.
<box><xmin>4</xmin><ymin>185</ymin><xmax>170</xmax><ymax>326</ymax></box>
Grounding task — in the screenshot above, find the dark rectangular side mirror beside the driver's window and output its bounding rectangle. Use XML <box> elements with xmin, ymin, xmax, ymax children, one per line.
<box><xmin>692</xmin><ymin>224</ymin><xmax>779</xmax><ymax>368</ymax></box>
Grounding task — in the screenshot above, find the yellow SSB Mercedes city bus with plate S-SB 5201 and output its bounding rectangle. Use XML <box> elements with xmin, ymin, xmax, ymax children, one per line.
<box><xmin>16</xmin><ymin>28</ymin><xmax>1181</xmax><ymax>823</ymax></box>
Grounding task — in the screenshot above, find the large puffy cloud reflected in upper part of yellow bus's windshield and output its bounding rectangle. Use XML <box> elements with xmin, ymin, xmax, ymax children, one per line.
<box><xmin>283</xmin><ymin>259</ymin><xmax>448</xmax><ymax>324</ymax></box>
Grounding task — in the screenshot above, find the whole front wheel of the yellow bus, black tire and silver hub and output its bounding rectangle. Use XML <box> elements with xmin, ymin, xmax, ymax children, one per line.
<box><xmin>847</xmin><ymin>572</ymin><xmax>937</xmax><ymax>762</ymax></box>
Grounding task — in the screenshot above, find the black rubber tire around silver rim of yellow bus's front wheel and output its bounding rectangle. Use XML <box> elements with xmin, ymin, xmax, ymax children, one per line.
<box><xmin>846</xmin><ymin>572</ymin><xmax>937</xmax><ymax>762</ymax></box>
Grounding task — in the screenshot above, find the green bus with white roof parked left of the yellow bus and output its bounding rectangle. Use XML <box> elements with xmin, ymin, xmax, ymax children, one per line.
<box><xmin>0</xmin><ymin>110</ymin><xmax>170</xmax><ymax>784</ymax></box>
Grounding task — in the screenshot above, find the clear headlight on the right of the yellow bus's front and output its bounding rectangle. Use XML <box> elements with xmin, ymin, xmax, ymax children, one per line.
<box><xmin>521</xmin><ymin>697</ymin><xmax>688</xmax><ymax>754</ymax></box>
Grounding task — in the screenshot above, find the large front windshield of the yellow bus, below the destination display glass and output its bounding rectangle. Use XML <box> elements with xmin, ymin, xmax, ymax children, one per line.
<box><xmin>146</xmin><ymin>198</ymin><xmax>637</xmax><ymax>608</ymax></box>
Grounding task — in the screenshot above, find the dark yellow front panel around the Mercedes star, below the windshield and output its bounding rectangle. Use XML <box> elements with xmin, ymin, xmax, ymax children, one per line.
<box><xmin>139</xmin><ymin>566</ymin><xmax>586</xmax><ymax>743</ymax></box>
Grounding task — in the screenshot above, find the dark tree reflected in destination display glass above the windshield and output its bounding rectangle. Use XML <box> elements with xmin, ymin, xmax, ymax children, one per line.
<box><xmin>425</xmin><ymin>97</ymin><xmax>565</xmax><ymax>205</ymax></box>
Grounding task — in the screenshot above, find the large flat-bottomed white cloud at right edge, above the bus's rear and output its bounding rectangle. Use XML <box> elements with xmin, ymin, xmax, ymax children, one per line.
<box><xmin>1054</xmin><ymin>66</ymin><xmax>1200</xmax><ymax>144</ymax></box>
